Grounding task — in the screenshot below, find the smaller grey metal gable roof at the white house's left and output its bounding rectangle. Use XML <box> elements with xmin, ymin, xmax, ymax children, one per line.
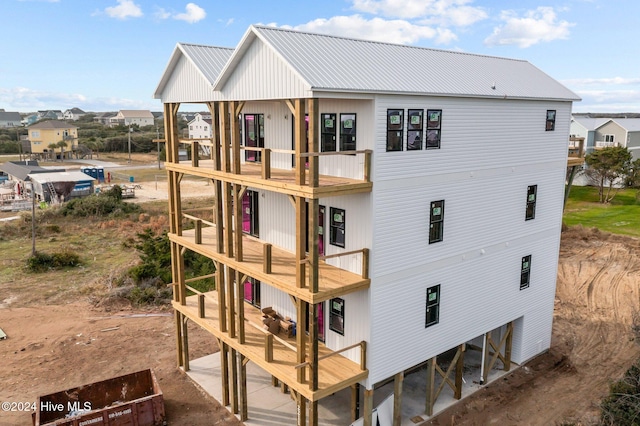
<box><xmin>153</xmin><ymin>43</ymin><xmax>234</xmax><ymax>98</ymax></box>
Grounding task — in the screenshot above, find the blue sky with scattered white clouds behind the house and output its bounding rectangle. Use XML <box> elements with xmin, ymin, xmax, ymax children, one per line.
<box><xmin>0</xmin><ymin>0</ymin><xmax>640</xmax><ymax>112</ymax></box>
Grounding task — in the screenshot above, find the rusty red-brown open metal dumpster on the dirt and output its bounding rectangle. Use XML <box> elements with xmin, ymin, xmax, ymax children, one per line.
<box><xmin>32</xmin><ymin>370</ymin><xmax>166</xmax><ymax>426</ymax></box>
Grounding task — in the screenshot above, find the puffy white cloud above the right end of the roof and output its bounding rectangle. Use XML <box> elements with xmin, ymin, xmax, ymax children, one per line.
<box><xmin>484</xmin><ymin>7</ymin><xmax>575</xmax><ymax>48</ymax></box>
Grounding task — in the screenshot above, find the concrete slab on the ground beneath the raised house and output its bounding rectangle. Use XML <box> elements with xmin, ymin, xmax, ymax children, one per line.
<box><xmin>187</xmin><ymin>350</ymin><xmax>518</xmax><ymax>426</ymax></box>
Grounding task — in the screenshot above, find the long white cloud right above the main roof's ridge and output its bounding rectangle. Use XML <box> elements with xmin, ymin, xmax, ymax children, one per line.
<box><xmin>280</xmin><ymin>15</ymin><xmax>456</xmax><ymax>44</ymax></box>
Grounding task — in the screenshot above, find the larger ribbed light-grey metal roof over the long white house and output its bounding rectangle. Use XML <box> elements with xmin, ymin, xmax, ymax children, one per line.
<box><xmin>214</xmin><ymin>26</ymin><xmax>580</xmax><ymax>101</ymax></box>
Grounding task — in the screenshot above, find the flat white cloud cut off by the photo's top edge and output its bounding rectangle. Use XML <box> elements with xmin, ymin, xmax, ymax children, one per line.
<box><xmin>353</xmin><ymin>0</ymin><xmax>487</xmax><ymax>27</ymax></box>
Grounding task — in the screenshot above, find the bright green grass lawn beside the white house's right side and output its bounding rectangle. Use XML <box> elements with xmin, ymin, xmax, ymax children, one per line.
<box><xmin>563</xmin><ymin>186</ymin><xmax>640</xmax><ymax>237</ymax></box>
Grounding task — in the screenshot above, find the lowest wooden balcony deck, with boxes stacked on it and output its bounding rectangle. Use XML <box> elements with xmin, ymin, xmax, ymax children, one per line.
<box><xmin>172</xmin><ymin>292</ymin><xmax>369</xmax><ymax>401</ymax></box>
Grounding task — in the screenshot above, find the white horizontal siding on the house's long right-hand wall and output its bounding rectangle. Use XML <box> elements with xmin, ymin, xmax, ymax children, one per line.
<box><xmin>368</xmin><ymin>96</ymin><xmax>571</xmax><ymax>385</ymax></box>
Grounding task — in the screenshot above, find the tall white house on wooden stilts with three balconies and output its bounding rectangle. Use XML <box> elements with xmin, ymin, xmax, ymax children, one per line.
<box><xmin>154</xmin><ymin>26</ymin><xmax>579</xmax><ymax>425</ymax></box>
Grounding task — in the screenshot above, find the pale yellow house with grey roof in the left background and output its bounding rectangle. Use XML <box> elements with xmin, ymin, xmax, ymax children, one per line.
<box><xmin>27</xmin><ymin>120</ymin><xmax>78</xmax><ymax>158</ymax></box>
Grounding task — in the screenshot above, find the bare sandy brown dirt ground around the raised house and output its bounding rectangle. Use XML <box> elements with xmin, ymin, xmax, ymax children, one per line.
<box><xmin>0</xmin><ymin>191</ymin><xmax>640</xmax><ymax>426</ymax></box>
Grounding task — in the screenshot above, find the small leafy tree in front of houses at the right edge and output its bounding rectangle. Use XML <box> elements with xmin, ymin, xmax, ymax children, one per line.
<box><xmin>585</xmin><ymin>146</ymin><xmax>631</xmax><ymax>203</ymax></box>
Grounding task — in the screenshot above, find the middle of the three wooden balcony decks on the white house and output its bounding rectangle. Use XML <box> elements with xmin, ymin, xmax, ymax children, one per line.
<box><xmin>169</xmin><ymin>221</ymin><xmax>371</xmax><ymax>304</ymax></box>
